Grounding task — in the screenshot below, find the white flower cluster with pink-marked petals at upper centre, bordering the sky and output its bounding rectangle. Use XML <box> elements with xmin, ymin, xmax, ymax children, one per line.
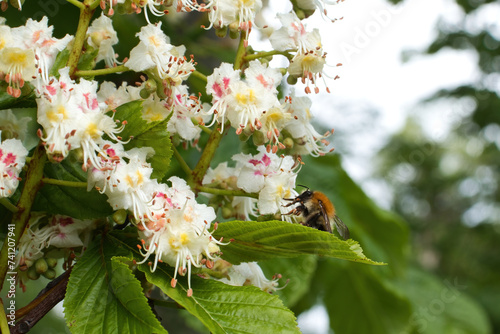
<box><xmin>206</xmin><ymin>61</ymin><xmax>330</xmax><ymax>156</ymax></box>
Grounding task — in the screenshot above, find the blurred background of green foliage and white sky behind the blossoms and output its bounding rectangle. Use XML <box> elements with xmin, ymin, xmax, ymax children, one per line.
<box><xmin>2</xmin><ymin>0</ymin><xmax>500</xmax><ymax>334</ymax></box>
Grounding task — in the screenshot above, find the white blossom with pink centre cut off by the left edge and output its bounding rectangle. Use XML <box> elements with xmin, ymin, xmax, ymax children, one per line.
<box><xmin>0</xmin><ymin>134</ymin><xmax>28</xmax><ymax>198</ymax></box>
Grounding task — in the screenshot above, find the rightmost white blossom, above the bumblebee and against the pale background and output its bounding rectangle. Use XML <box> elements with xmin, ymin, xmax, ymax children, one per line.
<box><xmin>284</xmin><ymin>93</ymin><xmax>333</xmax><ymax>157</ymax></box>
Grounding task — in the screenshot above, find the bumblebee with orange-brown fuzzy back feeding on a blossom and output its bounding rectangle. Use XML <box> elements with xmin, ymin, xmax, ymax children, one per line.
<box><xmin>285</xmin><ymin>186</ymin><xmax>350</xmax><ymax>240</ymax></box>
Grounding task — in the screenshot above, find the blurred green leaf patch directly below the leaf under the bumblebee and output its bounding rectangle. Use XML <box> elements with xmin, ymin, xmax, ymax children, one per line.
<box><xmin>259</xmin><ymin>255</ymin><xmax>318</xmax><ymax>307</ymax></box>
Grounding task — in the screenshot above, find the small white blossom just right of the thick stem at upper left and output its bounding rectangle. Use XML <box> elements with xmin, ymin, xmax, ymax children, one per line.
<box><xmin>87</xmin><ymin>12</ymin><xmax>118</xmax><ymax>67</ymax></box>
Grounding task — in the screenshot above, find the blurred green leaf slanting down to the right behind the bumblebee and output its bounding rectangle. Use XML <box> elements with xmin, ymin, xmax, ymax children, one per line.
<box><xmin>297</xmin><ymin>155</ymin><xmax>409</xmax><ymax>273</ymax></box>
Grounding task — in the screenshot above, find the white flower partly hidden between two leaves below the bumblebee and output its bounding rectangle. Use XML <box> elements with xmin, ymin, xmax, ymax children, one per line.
<box><xmin>219</xmin><ymin>262</ymin><xmax>281</xmax><ymax>293</ymax></box>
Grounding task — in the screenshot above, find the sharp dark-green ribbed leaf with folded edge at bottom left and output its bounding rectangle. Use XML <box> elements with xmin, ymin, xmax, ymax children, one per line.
<box><xmin>64</xmin><ymin>236</ymin><xmax>166</xmax><ymax>334</ymax></box>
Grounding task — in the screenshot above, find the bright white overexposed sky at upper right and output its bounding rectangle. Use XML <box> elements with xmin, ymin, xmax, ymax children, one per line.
<box><xmin>250</xmin><ymin>0</ymin><xmax>480</xmax><ymax>334</ymax></box>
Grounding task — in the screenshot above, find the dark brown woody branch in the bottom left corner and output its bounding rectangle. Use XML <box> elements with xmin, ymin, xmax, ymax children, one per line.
<box><xmin>10</xmin><ymin>269</ymin><xmax>71</xmax><ymax>334</ymax></box>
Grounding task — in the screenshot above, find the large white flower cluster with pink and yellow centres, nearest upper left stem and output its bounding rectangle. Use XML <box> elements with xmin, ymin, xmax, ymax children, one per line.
<box><xmin>37</xmin><ymin>68</ymin><xmax>123</xmax><ymax>168</ymax></box>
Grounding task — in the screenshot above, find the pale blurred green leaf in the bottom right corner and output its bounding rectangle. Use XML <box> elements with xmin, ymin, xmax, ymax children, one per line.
<box><xmin>397</xmin><ymin>268</ymin><xmax>491</xmax><ymax>334</ymax></box>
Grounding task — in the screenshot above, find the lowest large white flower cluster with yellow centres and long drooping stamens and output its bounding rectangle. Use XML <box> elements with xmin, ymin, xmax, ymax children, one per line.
<box><xmin>138</xmin><ymin>176</ymin><xmax>220</xmax><ymax>296</ymax></box>
